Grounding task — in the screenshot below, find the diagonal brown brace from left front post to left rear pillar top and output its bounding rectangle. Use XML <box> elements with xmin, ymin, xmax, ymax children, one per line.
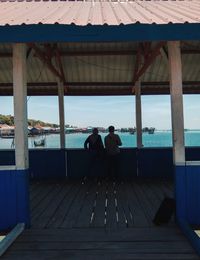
<box><xmin>28</xmin><ymin>43</ymin><xmax>64</xmax><ymax>81</ymax></box>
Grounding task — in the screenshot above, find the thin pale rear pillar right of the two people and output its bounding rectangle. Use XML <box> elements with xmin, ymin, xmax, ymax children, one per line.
<box><xmin>135</xmin><ymin>81</ymin><xmax>143</xmax><ymax>149</ymax></box>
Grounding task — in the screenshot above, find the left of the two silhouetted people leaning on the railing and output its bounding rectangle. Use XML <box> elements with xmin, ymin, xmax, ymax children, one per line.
<box><xmin>84</xmin><ymin>128</ymin><xmax>104</xmax><ymax>178</ymax></box>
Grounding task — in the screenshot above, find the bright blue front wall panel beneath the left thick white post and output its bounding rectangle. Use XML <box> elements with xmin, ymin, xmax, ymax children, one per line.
<box><xmin>0</xmin><ymin>170</ymin><xmax>30</xmax><ymax>231</ymax></box>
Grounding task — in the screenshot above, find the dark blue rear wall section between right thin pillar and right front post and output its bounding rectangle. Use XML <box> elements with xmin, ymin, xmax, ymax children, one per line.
<box><xmin>138</xmin><ymin>148</ymin><xmax>173</xmax><ymax>178</ymax></box>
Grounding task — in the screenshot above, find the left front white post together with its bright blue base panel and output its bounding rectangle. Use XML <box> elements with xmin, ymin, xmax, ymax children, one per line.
<box><xmin>0</xmin><ymin>43</ymin><xmax>30</xmax><ymax>230</ymax></box>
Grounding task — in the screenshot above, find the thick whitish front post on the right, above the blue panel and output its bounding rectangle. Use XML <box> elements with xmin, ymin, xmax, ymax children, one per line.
<box><xmin>168</xmin><ymin>41</ymin><xmax>185</xmax><ymax>165</ymax></box>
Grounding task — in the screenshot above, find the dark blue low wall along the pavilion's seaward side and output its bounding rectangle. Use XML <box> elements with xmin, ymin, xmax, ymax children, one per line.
<box><xmin>0</xmin><ymin>147</ymin><xmax>200</xmax><ymax>179</ymax></box>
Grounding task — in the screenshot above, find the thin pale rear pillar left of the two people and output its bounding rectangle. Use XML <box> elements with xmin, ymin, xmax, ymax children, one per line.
<box><xmin>58</xmin><ymin>80</ymin><xmax>65</xmax><ymax>149</ymax></box>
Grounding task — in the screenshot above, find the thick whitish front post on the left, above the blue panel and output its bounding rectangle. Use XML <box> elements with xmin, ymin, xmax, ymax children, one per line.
<box><xmin>13</xmin><ymin>43</ymin><xmax>29</xmax><ymax>169</ymax></box>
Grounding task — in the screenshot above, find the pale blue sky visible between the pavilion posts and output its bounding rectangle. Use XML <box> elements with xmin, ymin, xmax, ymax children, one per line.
<box><xmin>0</xmin><ymin>95</ymin><xmax>200</xmax><ymax>129</ymax></box>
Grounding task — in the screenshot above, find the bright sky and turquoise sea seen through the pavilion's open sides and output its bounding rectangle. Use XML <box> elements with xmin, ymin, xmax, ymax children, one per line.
<box><xmin>0</xmin><ymin>95</ymin><xmax>200</xmax><ymax>149</ymax></box>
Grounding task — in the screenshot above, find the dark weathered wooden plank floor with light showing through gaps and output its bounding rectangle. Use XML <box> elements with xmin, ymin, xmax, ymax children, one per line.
<box><xmin>3</xmin><ymin>180</ymin><xmax>199</xmax><ymax>260</ymax></box>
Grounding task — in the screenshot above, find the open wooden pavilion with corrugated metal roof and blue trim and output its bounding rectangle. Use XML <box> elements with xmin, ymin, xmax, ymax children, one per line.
<box><xmin>0</xmin><ymin>0</ymin><xmax>200</xmax><ymax>259</ymax></box>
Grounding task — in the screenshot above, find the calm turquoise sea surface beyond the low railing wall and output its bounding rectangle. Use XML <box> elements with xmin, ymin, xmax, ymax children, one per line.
<box><xmin>0</xmin><ymin>131</ymin><xmax>200</xmax><ymax>149</ymax></box>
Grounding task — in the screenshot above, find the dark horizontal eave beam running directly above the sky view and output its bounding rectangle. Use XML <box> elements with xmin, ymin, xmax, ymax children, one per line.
<box><xmin>0</xmin><ymin>81</ymin><xmax>200</xmax><ymax>96</ymax></box>
